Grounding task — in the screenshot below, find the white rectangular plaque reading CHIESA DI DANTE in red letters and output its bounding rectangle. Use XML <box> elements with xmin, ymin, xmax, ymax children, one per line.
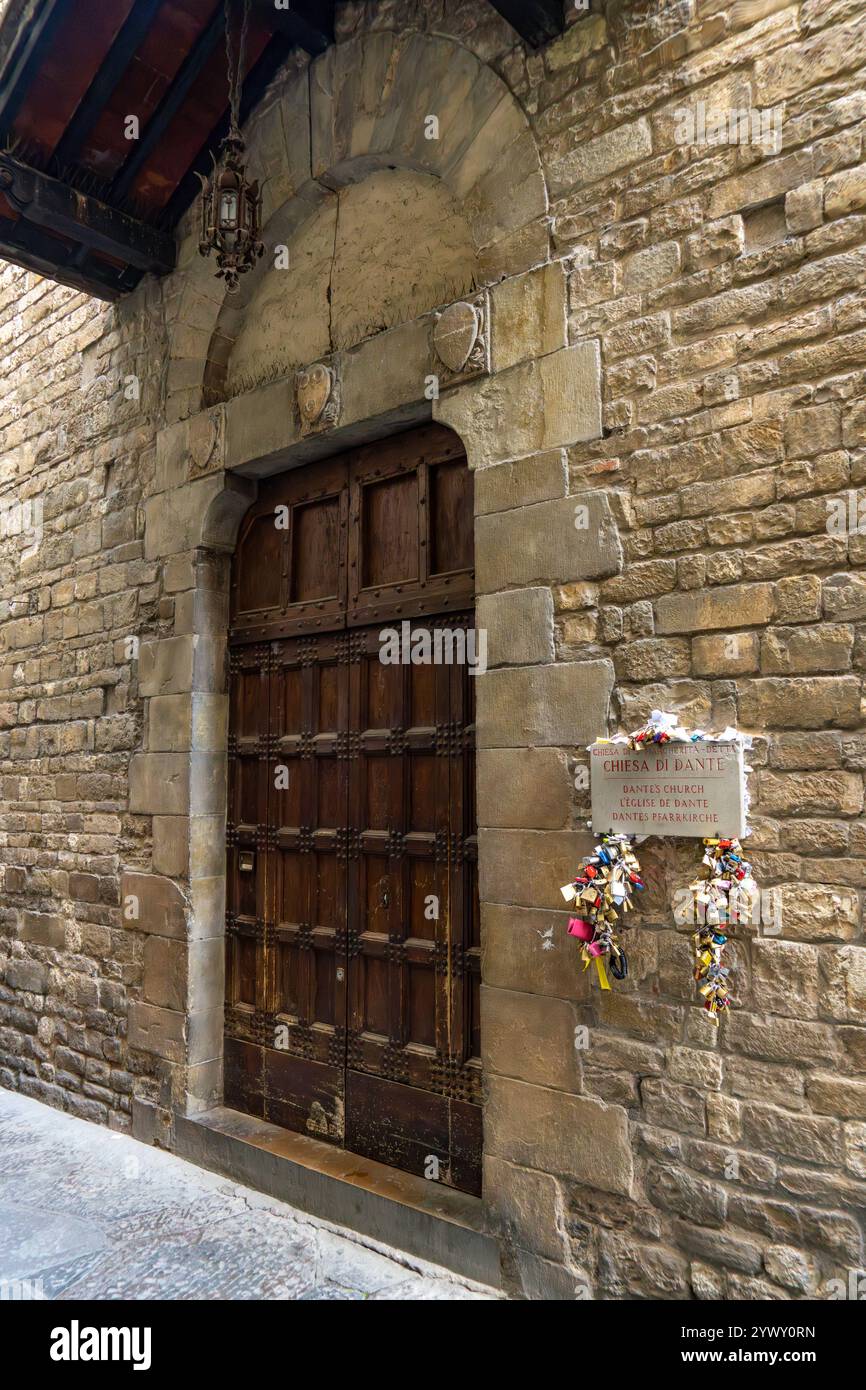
<box><xmin>589</xmin><ymin>742</ymin><xmax>745</xmax><ymax>840</ymax></box>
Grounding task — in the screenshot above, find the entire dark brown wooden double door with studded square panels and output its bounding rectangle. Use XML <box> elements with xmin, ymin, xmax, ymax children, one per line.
<box><xmin>225</xmin><ymin>425</ymin><xmax>481</xmax><ymax>1193</ymax></box>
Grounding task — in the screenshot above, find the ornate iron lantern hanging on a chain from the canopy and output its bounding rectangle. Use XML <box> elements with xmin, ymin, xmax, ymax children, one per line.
<box><xmin>199</xmin><ymin>0</ymin><xmax>264</xmax><ymax>295</ymax></box>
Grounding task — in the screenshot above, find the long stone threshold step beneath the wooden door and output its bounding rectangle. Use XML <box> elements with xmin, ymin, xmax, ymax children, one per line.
<box><xmin>172</xmin><ymin>1106</ymin><xmax>502</xmax><ymax>1289</ymax></box>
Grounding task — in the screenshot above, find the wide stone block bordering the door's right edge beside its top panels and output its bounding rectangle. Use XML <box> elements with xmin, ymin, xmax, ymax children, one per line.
<box><xmin>475</xmin><ymin>492</ymin><xmax>623</xmax><ymax>594</ymax></box>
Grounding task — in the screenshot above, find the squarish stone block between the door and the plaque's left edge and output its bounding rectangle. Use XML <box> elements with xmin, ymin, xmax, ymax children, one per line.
<box><xmin>477</xmin><ymin>748</ymin><xmax>573</xmax><ymax>830</ymax></box>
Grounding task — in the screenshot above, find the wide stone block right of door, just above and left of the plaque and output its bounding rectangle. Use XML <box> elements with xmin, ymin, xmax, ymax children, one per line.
<box><xmin>477</xmin><ymin>660</ymin><xmax>613</xmax><ymax>748</ymax></box>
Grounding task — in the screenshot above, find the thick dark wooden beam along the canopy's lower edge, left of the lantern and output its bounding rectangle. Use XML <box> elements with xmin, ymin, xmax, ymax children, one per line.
<box><xmin>0</xmin><ymin>152</ymin><xmax>177</xmax><ymax>275</ymax></box>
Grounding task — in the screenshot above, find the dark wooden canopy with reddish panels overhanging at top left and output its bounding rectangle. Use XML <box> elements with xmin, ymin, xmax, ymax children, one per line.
<box><xmin>0</xmin><ymin>0</ymin><xmax>566</xmax><ymax>299</ymax></box>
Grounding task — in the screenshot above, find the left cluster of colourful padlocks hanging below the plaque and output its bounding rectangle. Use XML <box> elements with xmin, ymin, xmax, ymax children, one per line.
<box><xmin>560</xmin><ymin>835</ymin><xmax>644</xmax><ymax>990</ymax></box>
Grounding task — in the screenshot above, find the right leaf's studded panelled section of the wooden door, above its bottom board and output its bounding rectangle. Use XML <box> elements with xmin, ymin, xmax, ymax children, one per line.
<box><xmin>348</xmin><ymin>614</ymin><xmax>480</xmax><ymax>1099</ymax></box>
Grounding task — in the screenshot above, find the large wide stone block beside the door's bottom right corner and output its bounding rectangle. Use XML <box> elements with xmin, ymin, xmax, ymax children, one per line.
<box><xmin>484</xmin><ymin>1076</ymin><xmax>632</xmax><ymax>1197</ymax></box>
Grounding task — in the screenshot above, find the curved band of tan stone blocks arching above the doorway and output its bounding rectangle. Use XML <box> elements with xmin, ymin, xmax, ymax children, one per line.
<box><xmin>167</xmin><ymin>31</ymin><xmax>549</xmax><ymax>420</ymax></box>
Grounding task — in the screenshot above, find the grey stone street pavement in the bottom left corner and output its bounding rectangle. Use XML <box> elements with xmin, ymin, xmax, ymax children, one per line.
<box><xmin>0</xmin><ymin>1090</ymin><xmax>493</xmax><ymax>1300</ymax></box>
